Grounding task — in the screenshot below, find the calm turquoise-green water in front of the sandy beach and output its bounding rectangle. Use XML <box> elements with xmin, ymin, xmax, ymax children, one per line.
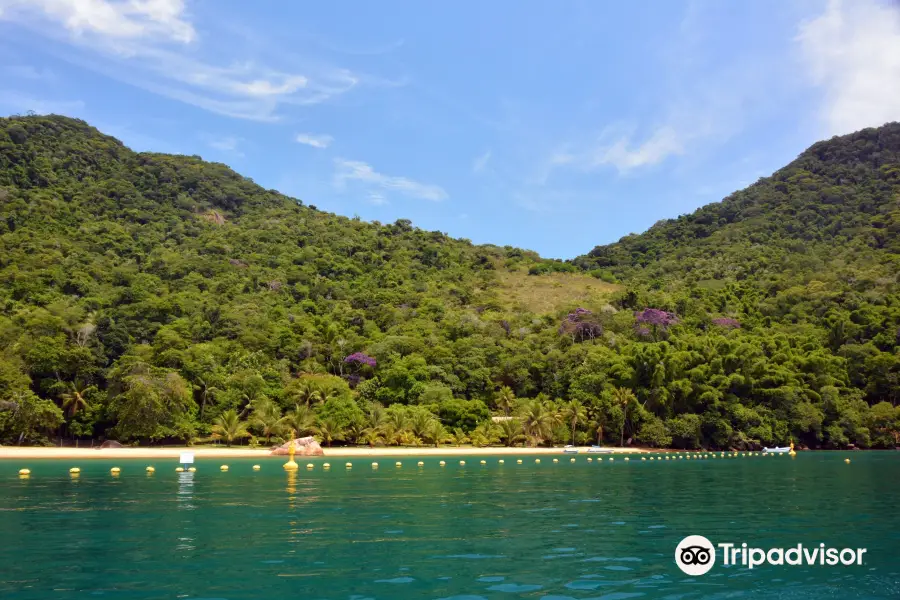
<box><xmin>0</xmin><ymin>452</ymin><xmax>900</xmax><ymax>600</ymax></box>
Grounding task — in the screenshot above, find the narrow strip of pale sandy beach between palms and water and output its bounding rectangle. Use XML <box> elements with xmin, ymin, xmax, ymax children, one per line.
<box><xmin>0</xmin><ymin>446</ymin><xmax>648</xmax><ymax>460</ymax></box>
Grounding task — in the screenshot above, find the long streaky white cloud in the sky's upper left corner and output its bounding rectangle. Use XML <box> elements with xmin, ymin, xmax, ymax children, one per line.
<box><xmin>0</xmin><ymin>0</ymin><xmax>359</xmax><ymax>121</ymax></box>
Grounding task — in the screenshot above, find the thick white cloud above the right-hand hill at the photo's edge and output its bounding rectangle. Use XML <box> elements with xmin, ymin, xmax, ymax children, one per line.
<box><xmin>797</xmin><ymin>0</ymin><xmax>900</xmax><ymax>135</ymax></box>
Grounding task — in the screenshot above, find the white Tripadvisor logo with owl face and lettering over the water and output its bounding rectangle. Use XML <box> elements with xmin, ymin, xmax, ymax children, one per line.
<box><xmin>675</xmin><ymin>535</ymin><xmax>866</xmax><ymax>577</ymax></box>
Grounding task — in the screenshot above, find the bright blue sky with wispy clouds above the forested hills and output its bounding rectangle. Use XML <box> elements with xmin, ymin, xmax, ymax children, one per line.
<box><xmin>0</xmin><ymin>0</ymin><xmax>900</xmax><ymax>258</ymax></box>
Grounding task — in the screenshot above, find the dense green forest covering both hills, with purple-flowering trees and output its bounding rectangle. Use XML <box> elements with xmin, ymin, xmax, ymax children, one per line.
<box><xmin>0</xmin><ymin>116</ymin><xmax>900</xmax><ymax>448</ymax></box>
